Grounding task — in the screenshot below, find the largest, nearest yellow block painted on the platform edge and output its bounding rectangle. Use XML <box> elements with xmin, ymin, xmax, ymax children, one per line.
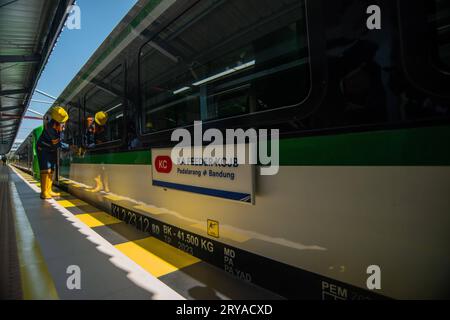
<box><xmin>115</xmin><ymin>237</ymin><xmax>201</xmax><ymax>278</ymax></box>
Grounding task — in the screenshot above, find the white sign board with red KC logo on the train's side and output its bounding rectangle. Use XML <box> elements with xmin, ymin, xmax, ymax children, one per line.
<box><xmin>152</xmin><ymin>149</ymin><xmax>255</xmax><ymax>204</ymax></box>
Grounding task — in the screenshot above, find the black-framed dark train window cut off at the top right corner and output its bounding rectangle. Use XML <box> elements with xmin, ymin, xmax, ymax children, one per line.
<box><xmin>398</xmin><ymin>0</ymin><xmax>450</xmax><ymax>103</ymax></box>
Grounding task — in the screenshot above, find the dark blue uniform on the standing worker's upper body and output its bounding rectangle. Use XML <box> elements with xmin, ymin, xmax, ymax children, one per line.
<box><xmin>37</xmin><ymin>120</ymin><xmax>69</xmax><ymax>171</ymax></box>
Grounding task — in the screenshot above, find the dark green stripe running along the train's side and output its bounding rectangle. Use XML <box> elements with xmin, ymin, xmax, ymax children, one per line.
<box><xmin>67</xmin><ymin>126</ymin><xmax>450</xmax><ymax>166</ymax></box>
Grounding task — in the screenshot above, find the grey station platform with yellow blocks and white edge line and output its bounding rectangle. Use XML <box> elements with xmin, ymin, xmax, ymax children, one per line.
<box><xmin>0</xmin><ymin>166</ymin><xmax>282</xmax><ymax>300</ymax></box>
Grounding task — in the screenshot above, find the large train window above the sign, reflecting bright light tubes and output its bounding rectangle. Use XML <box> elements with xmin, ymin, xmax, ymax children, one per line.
<box><xmin>140</xmin><ymin>0</ymin><xmax>310</xmax><ymax>133</ymax></box>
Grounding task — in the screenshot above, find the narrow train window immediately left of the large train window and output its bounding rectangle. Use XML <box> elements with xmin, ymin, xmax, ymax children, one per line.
<box><xmin>83</xmin><ymin>66</ymin><xmax>124</xmax><ymax>147</ymax></box>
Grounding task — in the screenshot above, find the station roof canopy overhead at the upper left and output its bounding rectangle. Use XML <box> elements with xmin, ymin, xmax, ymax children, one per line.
<box><xmin>0</xmin><ymin>0</ymin><xmax>74</xmax><ymax>155</ymax></box>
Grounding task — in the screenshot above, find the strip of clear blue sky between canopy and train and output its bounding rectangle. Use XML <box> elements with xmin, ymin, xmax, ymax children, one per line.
<box><xmin>16</xmin><ymin>0</ymin><xmax>137</xmax><ymax>141</ymax></box>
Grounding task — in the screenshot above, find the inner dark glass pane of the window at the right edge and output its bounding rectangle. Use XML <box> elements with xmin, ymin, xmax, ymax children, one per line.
<box><xmin>427</xmin><ymin>0</ymin><xmax>450</xmax><ymax>70</ymax></box>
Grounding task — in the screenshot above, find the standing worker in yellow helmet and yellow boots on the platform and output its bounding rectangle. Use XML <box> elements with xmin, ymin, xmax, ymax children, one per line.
<box><xmin>37</xmin><ymin>106</ymin><xmax>69</xmax><ymax>199</ymax></box>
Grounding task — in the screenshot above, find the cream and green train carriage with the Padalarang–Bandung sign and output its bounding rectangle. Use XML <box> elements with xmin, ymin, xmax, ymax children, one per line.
<box><xmin>13</xmin><ymin>0</ymin><xmax>450</xmax><ymax>300</ymax></box>
